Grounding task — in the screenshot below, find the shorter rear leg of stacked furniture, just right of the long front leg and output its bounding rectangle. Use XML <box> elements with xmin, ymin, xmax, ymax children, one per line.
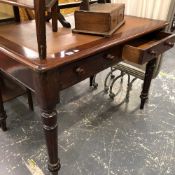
<box><xmin>51</xmin><ymin>2</ymin><xmax>58</xmax><ymax>32</ymax></box>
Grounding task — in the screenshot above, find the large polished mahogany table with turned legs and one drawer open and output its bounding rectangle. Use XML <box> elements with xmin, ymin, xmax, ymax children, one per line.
<box><xmin>0</xmin><ymin>16</ymin><xmax>175</xmax><ymax>174</ymax></box>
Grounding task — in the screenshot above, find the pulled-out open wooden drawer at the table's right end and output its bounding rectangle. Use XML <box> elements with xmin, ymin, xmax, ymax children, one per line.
<box><xmin>122</xmin><ymin>32</ymin><xmax>175</xmax><ymax>64</ymax></box>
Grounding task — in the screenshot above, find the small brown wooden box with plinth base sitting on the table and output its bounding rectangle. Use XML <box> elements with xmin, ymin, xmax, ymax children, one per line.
<box><xmin>73</xmin><ymin>3</ymin><xmax>125</xmax><ymax>36</ymax></box>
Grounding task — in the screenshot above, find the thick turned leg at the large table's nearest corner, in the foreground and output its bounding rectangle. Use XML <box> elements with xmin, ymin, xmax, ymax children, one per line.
<box><xmin>34</xmin><ymin>71</ymin><xmax>60</xmax><ymax>175</ymax></box>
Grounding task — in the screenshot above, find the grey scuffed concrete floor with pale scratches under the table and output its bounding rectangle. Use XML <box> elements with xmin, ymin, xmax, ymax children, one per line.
<box><xmin>0</xmin><ymin>49</ymin><xmax>175</xmax><ymax>175</ymax></box>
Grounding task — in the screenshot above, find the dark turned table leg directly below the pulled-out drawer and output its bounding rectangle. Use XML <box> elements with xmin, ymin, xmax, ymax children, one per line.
<box><xmin>140</xmin><ymin>58</ymin><xmax>156</xmax><ymax>109</ymax></box>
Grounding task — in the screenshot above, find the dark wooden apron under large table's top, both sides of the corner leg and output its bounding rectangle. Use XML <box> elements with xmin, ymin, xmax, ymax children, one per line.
<box><xmin>0</xmin><ymin>46</ymin><xmax>122</xmax><ymax>92</ymax></box>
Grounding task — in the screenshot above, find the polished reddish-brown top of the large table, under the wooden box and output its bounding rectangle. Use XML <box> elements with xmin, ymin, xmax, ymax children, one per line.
<box><xmin>0</xmin><ymin>16</ymin><xmax>167</xmax><ymax>70</ymax></box>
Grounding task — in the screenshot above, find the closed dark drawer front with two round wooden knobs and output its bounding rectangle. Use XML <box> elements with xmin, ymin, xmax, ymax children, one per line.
<box><xmin>58</xmin><ymin>47</ymin><xmax>121</xmax><ymax>90</ymax></box>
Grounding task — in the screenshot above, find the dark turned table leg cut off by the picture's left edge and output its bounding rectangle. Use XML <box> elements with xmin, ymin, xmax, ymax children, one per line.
<box><xmin>0</xmin><ymin>80</ymin><xmax>7</xmax><ymax>131</ymax></box>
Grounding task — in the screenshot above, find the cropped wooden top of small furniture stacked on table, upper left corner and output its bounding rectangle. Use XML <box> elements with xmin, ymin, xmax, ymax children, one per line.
<box><xmin>0</xmin><ymin>0</ymin><xmax>57</xmax><ymax>9</ymax></box>
